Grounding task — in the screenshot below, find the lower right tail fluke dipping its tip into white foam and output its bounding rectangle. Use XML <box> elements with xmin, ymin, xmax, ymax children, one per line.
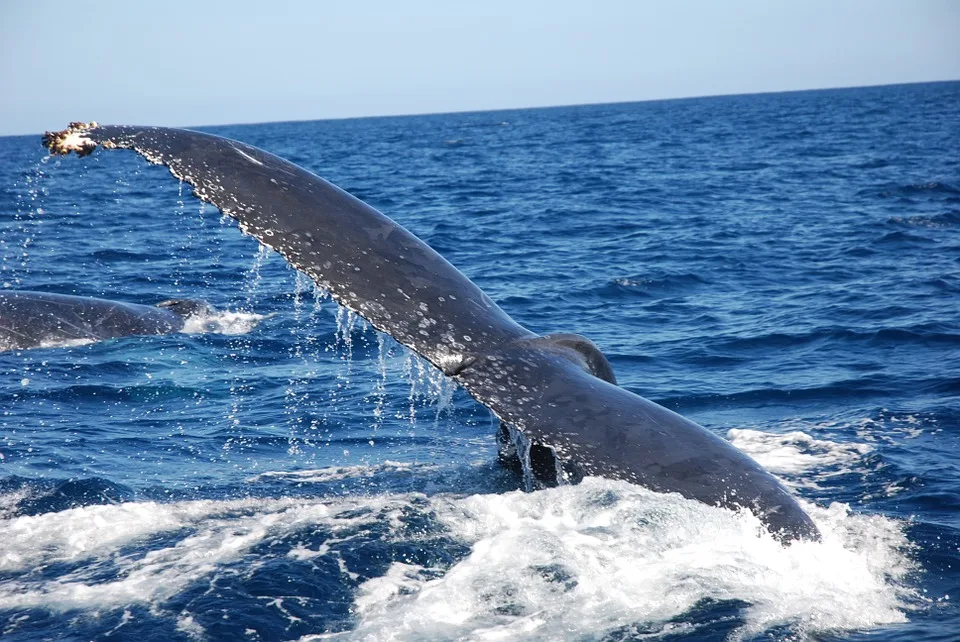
<box><xmin>456</xmin><ymin>339</ymin><xmax>820</xmax><ymax>541</ymax></box>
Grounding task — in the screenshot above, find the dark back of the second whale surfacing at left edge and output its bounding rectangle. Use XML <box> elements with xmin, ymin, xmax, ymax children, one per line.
<box><xmin>0</xmin><ymin>290</ymin><xmax>212</xmax><ymax>350</ymax></box>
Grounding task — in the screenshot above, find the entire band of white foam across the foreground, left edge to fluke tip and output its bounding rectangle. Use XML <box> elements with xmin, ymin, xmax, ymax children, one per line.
<box><xmin>0</xmin><ymin>478</ymin><xmax>918</xmax><ymax>640</ymax></box>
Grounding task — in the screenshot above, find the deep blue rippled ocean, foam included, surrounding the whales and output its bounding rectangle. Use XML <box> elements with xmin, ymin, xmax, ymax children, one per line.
<box><xmin>0</xmin><ymin>82</ymin><xmax>960</xmax><ymax>642</ymax></box>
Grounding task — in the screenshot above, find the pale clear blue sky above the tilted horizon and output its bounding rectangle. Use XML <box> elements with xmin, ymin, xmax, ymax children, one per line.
<box><xmin>0</xmin><ymin>0</ymin><xmax>960</xmax><ymax>135</ymax></box>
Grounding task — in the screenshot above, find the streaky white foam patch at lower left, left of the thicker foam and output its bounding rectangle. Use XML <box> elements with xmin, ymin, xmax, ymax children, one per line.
<box><xmin>0</xmin><ymin>498</ymin><xmax>389</xmax><ymax>611</ymax></box>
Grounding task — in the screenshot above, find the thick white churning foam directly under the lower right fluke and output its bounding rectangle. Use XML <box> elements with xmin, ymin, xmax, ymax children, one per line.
<box><xmin>314</xmin><ymin>478</ymin><xmax>914</xmax><ymax>640</ymax></box>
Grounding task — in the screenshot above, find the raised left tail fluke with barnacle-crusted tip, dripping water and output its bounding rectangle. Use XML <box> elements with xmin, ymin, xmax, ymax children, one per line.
<box><xmin>44</xmin><ymin>123</ymin><xmax>531</xmax><ymax>374</ymax></box>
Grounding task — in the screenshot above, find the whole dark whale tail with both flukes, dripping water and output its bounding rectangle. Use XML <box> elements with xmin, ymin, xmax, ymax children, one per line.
<box><xmin>43</xmin><ymin>123</ymin><xmax>820</xmax><ymax>543</ymax></box>
